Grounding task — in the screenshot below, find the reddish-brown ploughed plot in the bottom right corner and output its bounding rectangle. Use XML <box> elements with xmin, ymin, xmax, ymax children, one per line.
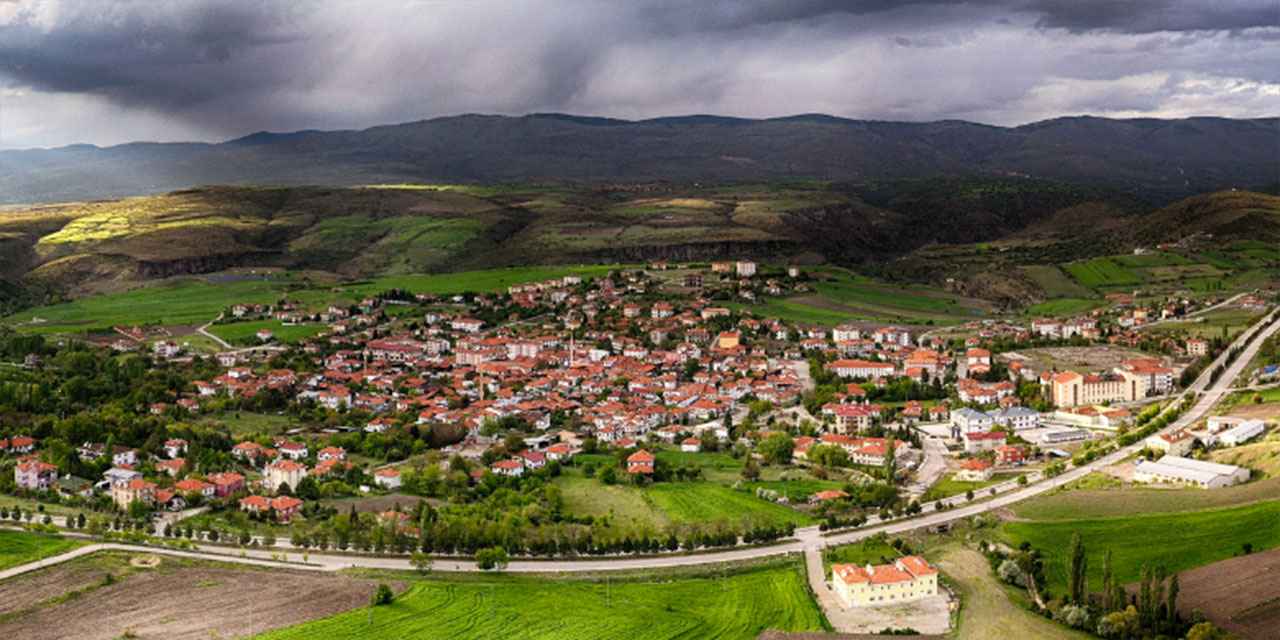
<box><xmin>1162</xmin><ymin>549</ymin><xmax>1280</xmax><ymax>640</ymax></box>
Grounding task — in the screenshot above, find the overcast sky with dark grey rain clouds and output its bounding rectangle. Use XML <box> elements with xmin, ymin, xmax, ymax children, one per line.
<box><xmin>0</xmin><ymin>0</ymin><xmax>1280</xmax><ymax>148</ymax></box>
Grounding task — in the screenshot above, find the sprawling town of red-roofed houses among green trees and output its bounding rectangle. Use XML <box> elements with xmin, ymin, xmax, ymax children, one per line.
<box><xmin>0</xmin><ymin>260</ymin><xmax>1276</xmax><ymax>630</ymax></box>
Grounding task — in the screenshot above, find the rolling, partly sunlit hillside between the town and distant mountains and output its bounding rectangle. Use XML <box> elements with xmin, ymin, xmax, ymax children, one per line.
<box><xmin>0</xmin><ymin>179</ymin><xmax>1147</xmax><ymax>311</ymax></box>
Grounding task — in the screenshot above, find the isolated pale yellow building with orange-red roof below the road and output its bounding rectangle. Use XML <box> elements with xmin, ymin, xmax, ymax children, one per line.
<box><xmin>831</xmin><ymin>556</ymin><xmax>938</xmax><ymax>607</ymax></box>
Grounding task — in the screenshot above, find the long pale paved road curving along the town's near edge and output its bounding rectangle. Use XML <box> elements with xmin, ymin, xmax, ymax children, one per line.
<box><xmin>0</xmin><ymin>309</ymin><xmax>1280</xmax><ymax>593</ymax></box>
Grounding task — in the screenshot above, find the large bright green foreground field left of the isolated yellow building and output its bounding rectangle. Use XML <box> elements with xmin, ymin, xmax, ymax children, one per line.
<box><xmin>257</xmin><ymin>562</ymin><xmax>827</xmax><ymax>640</ymax></box>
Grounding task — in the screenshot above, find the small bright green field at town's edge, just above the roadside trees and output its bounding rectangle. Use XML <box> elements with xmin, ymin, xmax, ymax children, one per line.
<box><xmin>645</xmin><ymin>483</ymin><xmax>815</xmax><ymax>526</ymax></box>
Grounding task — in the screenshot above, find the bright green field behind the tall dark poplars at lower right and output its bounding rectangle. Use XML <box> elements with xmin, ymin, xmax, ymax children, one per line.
<box><xmin>1000</xmin><ymin>500</ymin><xmax>1280</xmax><ymax>588</ymax></box>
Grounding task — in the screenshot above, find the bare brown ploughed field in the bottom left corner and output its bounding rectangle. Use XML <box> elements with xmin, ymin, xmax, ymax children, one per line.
<box><xmin>0</xmin><ymin>558</ymin><xmax>404</xmax><ymax>639</ymax></box>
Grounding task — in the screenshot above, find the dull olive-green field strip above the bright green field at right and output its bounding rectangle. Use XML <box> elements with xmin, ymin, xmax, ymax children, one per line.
<box><xmin>1011</xmin><ymin>476</ymin><xmax>1280</xmax><ymax>520</ymax></box>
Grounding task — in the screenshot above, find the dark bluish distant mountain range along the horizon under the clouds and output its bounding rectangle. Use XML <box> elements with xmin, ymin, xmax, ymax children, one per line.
<box><xmin>0</xmin><ymin>114</ymin><xmax>1280</xmax><ymax>204</ymax></box>
